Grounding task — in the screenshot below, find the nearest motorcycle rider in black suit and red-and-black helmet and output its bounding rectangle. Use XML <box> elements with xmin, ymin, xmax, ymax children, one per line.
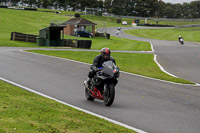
<box><xmin>84</xmin><ymin>48</ymin><xmax>116</xmax><ymax>87</ymax></box>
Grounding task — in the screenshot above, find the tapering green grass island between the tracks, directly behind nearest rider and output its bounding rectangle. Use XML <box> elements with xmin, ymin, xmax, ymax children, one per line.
<box><xmin>25</xmin><ymin>50</ymin><xmax>194</xmax><ymax>84</ymax></box>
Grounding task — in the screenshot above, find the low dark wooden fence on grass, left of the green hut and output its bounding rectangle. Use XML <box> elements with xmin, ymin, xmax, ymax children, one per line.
<box><xmin>10</xmin><ymin>32</ymin><xmax>38</xmax><ymax>43</ymax></box>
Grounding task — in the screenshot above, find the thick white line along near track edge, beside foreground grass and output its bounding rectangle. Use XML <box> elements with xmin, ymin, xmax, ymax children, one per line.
<box><xmin>0</xmin><ymin>77</ymin><xmax>147</xmax><ymax>133</ymax></box>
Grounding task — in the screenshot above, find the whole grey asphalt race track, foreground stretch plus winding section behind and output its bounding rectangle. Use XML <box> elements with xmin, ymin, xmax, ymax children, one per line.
<box><xmin>0</xmin><ymin>28</ymin><xmax>200</xmax><ymax>133</ymax></box>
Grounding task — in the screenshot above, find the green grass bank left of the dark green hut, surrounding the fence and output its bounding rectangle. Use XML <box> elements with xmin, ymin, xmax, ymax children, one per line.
<box><xmin>0</xmin><ymin>8</ymin><xmax>70</xmax><ymax>47</ymax></box>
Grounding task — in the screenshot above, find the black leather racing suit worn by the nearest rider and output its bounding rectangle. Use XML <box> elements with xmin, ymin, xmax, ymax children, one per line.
<box><xmin>88</xmin><ymin>55</ymin><xmax>116</xmax><ymax>78</ymax></box>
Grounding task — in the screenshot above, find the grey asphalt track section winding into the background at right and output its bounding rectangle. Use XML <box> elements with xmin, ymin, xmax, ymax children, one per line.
<box><xmin>106</xmin><ymin>27</ymin><xmax>200</xmax><ymax>83</ymax></box>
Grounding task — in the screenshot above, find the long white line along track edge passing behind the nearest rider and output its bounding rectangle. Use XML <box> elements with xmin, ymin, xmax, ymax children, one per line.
<box><xmin>20</xmin><ymin>50</ymin><xmax>200</xmax><ymax>86</ymax></box>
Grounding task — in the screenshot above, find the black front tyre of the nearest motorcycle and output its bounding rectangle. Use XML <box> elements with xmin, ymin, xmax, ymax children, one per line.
<box><xmin>103</xmin><ymin>85</ymin><xmax>115</xmax><ymax>106</ymax></box>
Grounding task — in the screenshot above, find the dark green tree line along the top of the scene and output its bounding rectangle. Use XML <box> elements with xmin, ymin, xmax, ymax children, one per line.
<box><xmin>0</xmin><ymin>0</ymin><xmax>200</xmax><ymax>19</ymax></box>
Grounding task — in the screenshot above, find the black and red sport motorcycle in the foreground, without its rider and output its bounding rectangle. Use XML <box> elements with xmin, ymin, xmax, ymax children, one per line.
<box><xmin>84</xmin><ymin>61</ymin><xmax>119</xmax><ymax>106</ymax></box>
